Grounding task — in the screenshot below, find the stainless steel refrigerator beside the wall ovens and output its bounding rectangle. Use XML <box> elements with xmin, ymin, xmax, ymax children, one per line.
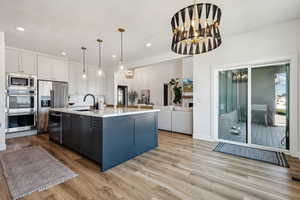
<box><xmin>37</xmin><ymin>80</ymin><xmax>68</xmax><ymax>133</ymax></box>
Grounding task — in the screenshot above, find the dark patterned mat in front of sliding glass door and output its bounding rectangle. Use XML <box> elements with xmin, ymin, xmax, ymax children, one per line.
<box><xmin>214</xmin><ymin>142</ymin><xmax>289</xmax><ymax>168</ymax></box>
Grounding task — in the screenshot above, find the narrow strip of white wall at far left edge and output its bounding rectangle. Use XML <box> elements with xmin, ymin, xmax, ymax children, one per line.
<box><xmin>0</xmin><ymin>32</ymin><xmax>6</xmax><ymax>151</ymax></box>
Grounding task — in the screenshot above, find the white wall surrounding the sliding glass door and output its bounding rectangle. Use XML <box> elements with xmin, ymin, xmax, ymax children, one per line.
<box><xmin>193</xmin><ymin>20</ymin><xmax>300</xmax><ymax>153</ymax></box>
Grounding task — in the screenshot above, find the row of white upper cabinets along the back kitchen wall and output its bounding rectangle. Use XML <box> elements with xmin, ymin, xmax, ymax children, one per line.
<box><xmin>6</xmin><ymin>48</ymin><xmax>105</xmax><ymax>96</ymax></box>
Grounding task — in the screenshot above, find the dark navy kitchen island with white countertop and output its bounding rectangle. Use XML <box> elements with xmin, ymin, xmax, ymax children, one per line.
<box><xmin>49</xmin><ymin>108</ymin><xmax>159</xmax><ymax>171</ymax></box>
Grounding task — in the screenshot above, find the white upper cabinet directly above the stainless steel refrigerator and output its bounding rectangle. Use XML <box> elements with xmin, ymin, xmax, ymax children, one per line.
<box><xmin>38</xmin><ymin>56</ymin><xmax>68</xmax><ymax>82</ymax></box>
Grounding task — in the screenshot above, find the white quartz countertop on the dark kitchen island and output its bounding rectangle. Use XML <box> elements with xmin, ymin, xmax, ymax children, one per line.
<box><xmin>50</xmin><ymin>108</ymin><xmax>160</xmax><ymax>117</ymax></box>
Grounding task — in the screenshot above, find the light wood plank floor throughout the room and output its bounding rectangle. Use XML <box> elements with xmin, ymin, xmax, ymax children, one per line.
<box><xmin>0</xmin><ymin>132</ymin><xmax>300</xmax><ymax>200</ymax></box>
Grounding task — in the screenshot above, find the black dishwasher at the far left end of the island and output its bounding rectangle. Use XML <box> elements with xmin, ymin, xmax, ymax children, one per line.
<box><xmin>48</xmin><ymin>111</ymin><xmax>62</xmax><ymax>144</ymax></box>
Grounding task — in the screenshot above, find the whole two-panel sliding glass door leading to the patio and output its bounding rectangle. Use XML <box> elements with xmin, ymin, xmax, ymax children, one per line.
<box><xmin>218</xmin><ymin>64</ymin><xmax>289</xmax><ymax>149</ymax></box>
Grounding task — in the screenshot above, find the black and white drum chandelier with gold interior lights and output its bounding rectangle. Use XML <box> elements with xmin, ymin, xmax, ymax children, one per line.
<box><xmin>171</xmin><ymin>2</ymin><xmax>222</xmax><ymax>55</ymax></box>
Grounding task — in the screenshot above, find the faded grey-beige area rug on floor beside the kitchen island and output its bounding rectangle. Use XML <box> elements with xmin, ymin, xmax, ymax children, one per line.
<box><xmin>0</xmin><ymin>146</ymin><xmax>77</xmax><ymax>200</ymax></box>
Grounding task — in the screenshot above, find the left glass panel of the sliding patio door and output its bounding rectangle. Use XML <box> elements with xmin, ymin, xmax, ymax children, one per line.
<box><xmin>218</xmin><ymin>68</ymin><xmax>248</xmax><ymax>143</ymax></box>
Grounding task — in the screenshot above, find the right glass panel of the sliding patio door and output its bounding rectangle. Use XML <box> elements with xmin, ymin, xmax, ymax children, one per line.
<box><xmin>251</xmin><ymin>65</ymin><xmax>289</xmax><ymax>149</ymax></box>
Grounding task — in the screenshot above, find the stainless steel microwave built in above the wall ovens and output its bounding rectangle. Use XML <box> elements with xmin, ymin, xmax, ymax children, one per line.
<box><xmin>7</xmin><ymin>74</ymin><xmax>36</xmax><ymax>89</ymax></box>
